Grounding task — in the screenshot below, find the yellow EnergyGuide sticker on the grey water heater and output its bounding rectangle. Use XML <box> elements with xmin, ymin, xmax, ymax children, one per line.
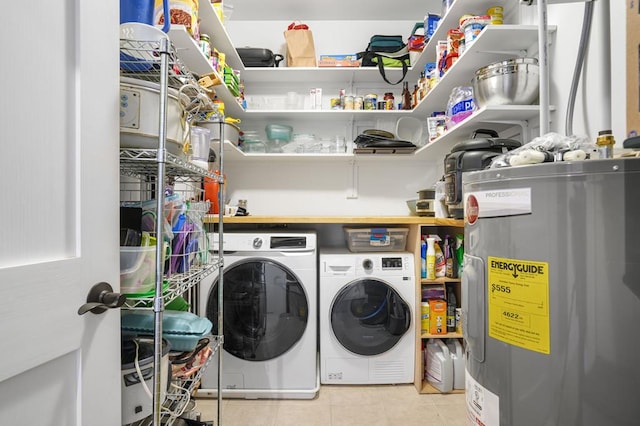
<box><xmin>487</xmin><ymin>256</ymin><xmax>550</xmax><ymax>354</ymax></box>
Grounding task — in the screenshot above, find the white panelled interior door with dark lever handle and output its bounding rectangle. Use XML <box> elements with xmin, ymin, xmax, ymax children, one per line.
<box><xmin>0</xmin><ymin>0</ymin><xmax>121</xmax><ymax>426</ymax></box>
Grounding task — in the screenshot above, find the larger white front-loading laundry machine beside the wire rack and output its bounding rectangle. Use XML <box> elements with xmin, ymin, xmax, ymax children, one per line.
<box><xmin>198</xmin><ymin>231</ymin><xmax>320</xmax><ymax>399</ymax></box>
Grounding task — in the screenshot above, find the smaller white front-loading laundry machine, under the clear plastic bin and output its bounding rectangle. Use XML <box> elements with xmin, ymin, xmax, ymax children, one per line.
<box><xmin>319</xmin><ymin>250</ymin><xmax>416</xmax><ymax>384</ymax></box>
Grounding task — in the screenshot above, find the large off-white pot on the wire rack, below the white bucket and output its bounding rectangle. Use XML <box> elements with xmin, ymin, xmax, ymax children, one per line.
<box><xmin>120</xmin><ymin>77</ymin><xmax>190</xmax><ymax>156</ymax></box>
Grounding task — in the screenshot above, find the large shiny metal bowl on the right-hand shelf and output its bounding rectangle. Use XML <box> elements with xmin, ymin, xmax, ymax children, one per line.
<box><xmin>472</xmin><ymin>58</ymin><xmax>540</xmax><ymax>108</ymax></box>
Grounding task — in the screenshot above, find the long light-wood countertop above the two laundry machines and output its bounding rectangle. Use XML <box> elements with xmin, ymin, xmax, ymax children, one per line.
<box><xmin>204</xmin><ymin>215</ymin><xmax>464</xmax><ymax>226</ymax></box>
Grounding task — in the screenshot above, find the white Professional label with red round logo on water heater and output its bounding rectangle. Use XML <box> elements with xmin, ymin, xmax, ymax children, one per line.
<box><xmin>464</xmin><ymin>188</ymin><xmax>531</xmax><ymax>224</ymax></box>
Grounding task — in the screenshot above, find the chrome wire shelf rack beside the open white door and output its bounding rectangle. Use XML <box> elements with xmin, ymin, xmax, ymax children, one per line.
<box><xmin>120</xmin><ymin>32</ymin><xmax>223</xmax><ymax>426</ymax></box>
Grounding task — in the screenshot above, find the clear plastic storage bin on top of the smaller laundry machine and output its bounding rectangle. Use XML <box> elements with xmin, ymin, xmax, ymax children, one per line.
<box><xmin>344</xmin><ymin>228</ymin><xmax>409</xmax><ymax>253</ymax></box>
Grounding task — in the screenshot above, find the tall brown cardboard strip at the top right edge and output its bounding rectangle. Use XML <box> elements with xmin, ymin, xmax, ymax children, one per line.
<box><xmin>627</xmin><ymin>0</ymin><xmax>640</xmax><ymax>137</ymax></box>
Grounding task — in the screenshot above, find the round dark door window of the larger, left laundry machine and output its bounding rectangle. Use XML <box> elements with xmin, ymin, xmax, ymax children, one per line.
<box><xmin>207</xmin><ymin>258</ymin><xmax>309</xmax><ymax>361</ymax></box>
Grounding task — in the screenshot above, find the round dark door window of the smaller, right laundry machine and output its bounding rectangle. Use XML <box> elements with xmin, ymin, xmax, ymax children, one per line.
<box><xmin>331</xmin><ymin>279</ymin><xmax>411</xmax><ymax>355</ymax></box>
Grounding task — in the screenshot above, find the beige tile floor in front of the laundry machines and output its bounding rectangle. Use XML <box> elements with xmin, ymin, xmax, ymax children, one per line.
<box><xmin>196</xmin><ymin>385</ymin><xmax>466</xmax><ymax>426</ymax></box>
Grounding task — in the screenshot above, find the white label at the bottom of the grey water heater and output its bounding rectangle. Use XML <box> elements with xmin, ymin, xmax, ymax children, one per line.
<box><xmin>464</xmin><ymin>369</ymin><xmax>500</xmax><ymax>426</ymax></box>
